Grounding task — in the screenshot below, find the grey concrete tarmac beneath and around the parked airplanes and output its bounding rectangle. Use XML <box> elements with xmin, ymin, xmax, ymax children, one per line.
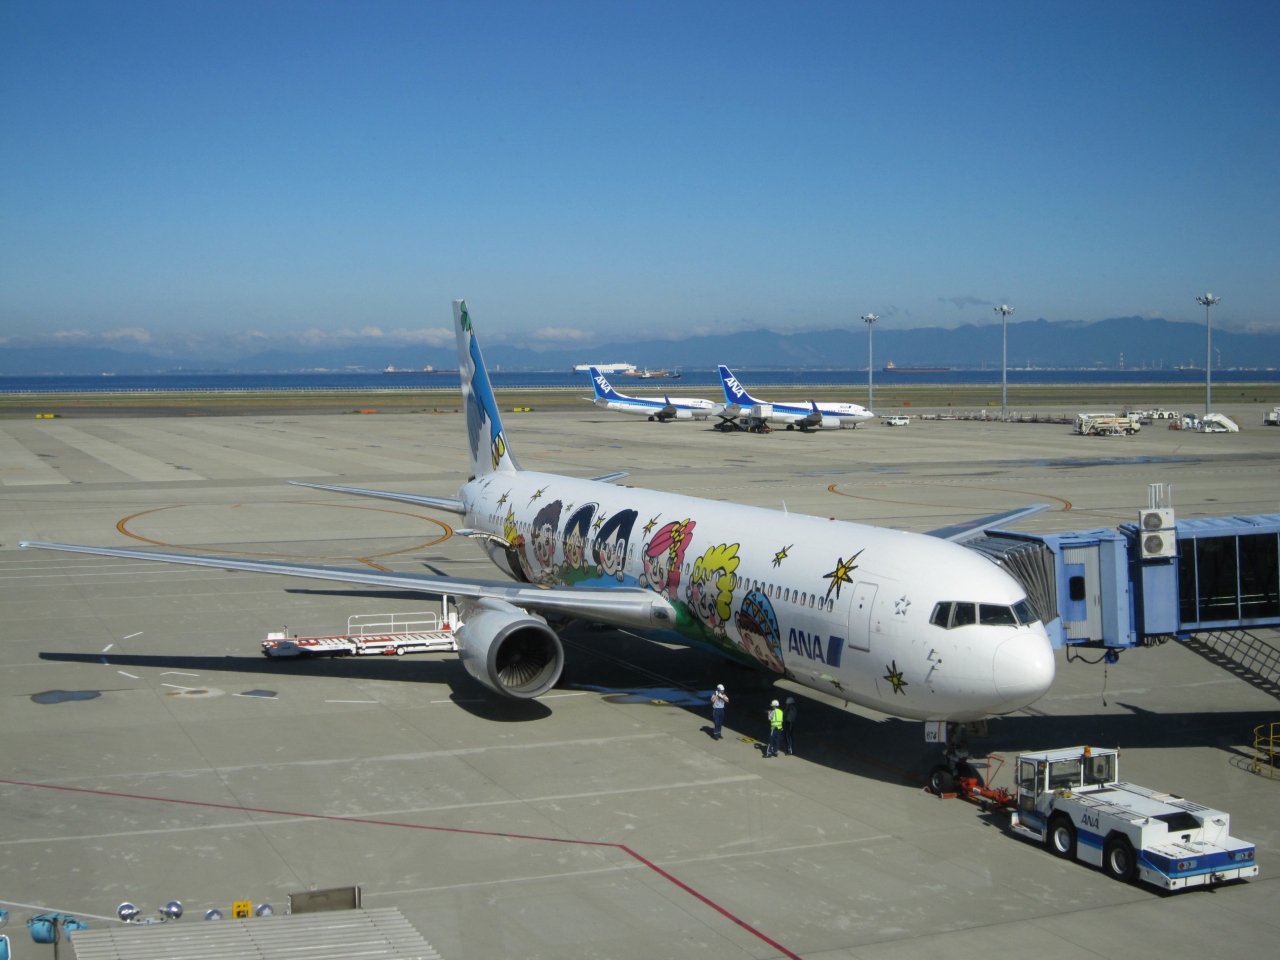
<box><xmin>0</xmin><ymin>404</ymin><xmax>1280</xmax><ymax>960</ymax></box>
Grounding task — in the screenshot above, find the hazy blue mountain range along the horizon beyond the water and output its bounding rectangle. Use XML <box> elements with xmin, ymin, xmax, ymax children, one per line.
<box><xmin>0</xmin><ymin>316</ymin><xmax>1280</xmax><ymax>376</ymax></box>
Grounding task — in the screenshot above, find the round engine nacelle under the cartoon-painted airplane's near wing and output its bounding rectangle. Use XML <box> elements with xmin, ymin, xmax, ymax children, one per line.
<box><xmin>453</xmin><ymin>599</ymin><xmax>564</xmax><ymax>700</ymax></box>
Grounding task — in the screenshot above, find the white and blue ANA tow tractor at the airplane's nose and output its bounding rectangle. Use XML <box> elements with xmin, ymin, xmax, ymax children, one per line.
<box><xmin>1011</xmin><ymin>746</ymin><xmax>1258</xmax><ymax>890</ymax></box>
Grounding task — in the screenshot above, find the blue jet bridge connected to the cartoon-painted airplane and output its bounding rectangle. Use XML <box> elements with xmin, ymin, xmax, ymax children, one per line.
<box><xmin>965</xmin><ymin>485</ymin><xmax>1280</xmax><ymax>649</ymax></box>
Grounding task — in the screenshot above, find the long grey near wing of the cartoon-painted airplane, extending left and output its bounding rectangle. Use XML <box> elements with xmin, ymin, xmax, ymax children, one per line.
<box><xmin>18</xmin><ymin>542</ymin><xmax>676</xmax><ymax>630</ymax></box>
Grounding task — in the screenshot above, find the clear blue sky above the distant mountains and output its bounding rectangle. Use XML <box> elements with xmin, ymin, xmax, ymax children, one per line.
<box><xmin>0</xmin><ymin>0</ymin><xmax>1280</xmax><ymax>348</ymax></box>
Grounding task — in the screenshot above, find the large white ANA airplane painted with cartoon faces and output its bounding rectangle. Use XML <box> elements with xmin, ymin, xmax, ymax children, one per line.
<box><xmin>20</xmin><ymin>301</ymin><xmax>1055</xmax><ymax>783</ymax></box>
